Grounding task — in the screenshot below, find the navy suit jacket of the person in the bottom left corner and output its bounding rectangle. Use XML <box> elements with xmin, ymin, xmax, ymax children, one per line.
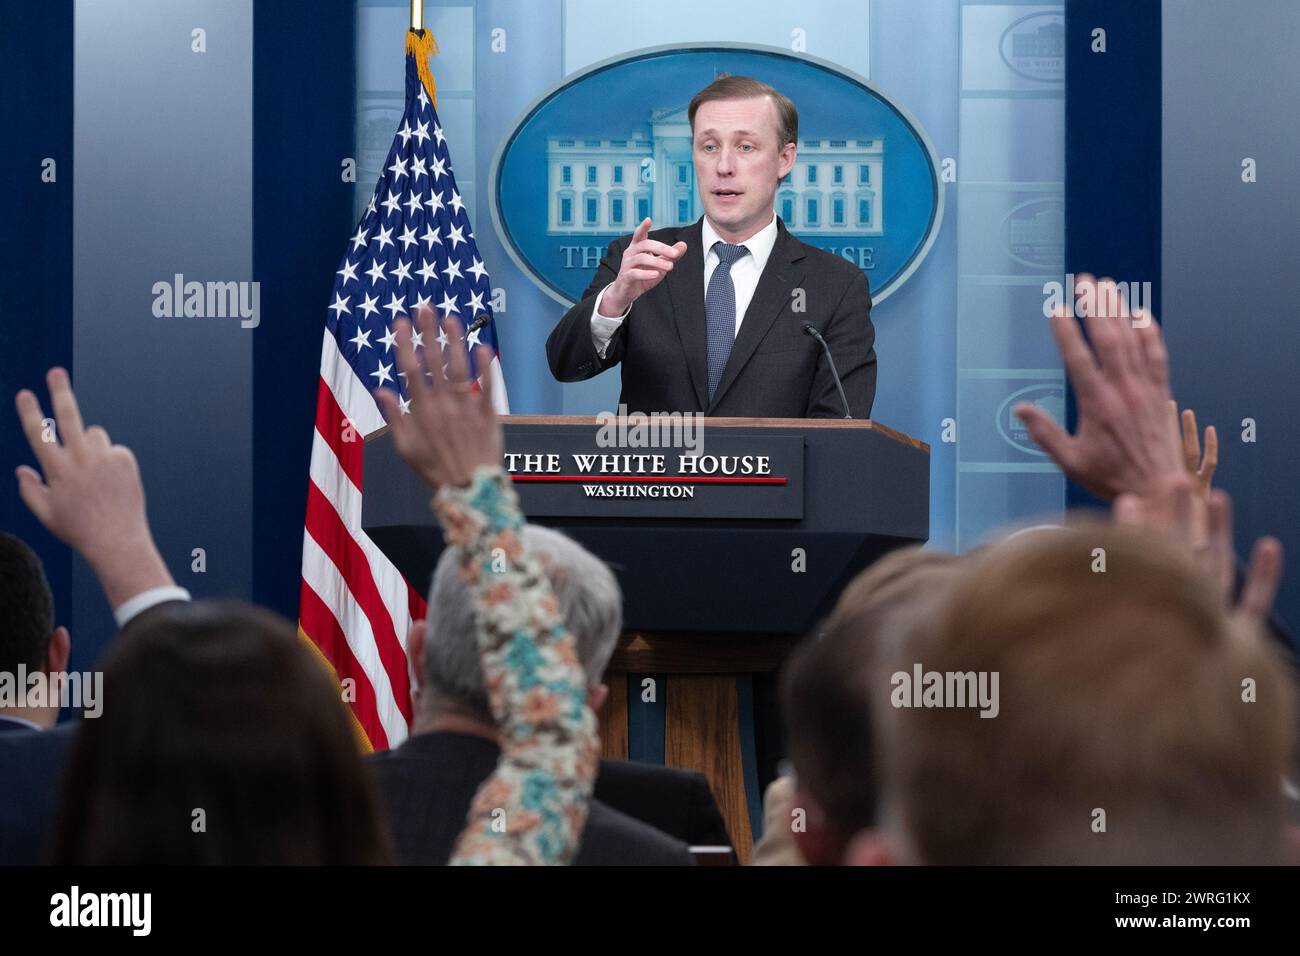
<box><xmin>0</xmin><ymin>718</ymin><xmax>81</xmax><ymax>866</ymax></box>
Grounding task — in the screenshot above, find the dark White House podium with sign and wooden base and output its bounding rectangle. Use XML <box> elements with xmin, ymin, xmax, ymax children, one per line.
<box><xmin>363</xmin><ymin>415</ymin><xmax>930</xmax><ymax>862</ymax></box>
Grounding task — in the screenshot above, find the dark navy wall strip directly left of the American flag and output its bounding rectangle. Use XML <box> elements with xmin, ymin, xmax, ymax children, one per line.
<box><xmin>252</xmin><ymin>0</ymin><xmax>358</xmax><ymax>620</ymax></box>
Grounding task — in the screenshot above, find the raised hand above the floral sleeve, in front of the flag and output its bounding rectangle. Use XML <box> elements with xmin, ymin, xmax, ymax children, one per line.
<box><xmin>374</xmin><ymin>310</ymin><xmax>502</xmax><ymax>492</ymax></box>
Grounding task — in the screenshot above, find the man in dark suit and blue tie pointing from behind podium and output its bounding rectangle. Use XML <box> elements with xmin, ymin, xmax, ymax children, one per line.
<box><xmin>546</xmin><ymin>75</ymin><xmax>876</xmax><ymax>419</ymax></box>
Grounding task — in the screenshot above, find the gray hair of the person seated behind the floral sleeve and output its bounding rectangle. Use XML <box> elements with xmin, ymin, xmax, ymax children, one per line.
<box><xmin>424</xmin><ymin>524</ymin><xmax>623</xmax><ymax>714</ymax></box>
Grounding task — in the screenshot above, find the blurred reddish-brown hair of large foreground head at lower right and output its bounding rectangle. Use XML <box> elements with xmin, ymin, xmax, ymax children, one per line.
<box><xmin>878</xmin><ymin>524</ymin><xmax>1295</xmax><ymax>865</ymax></box>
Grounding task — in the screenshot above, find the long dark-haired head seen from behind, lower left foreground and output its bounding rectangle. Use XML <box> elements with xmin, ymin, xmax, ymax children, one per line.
<box><xmin>55</xmin><ymin>601</ymin><xmax>391</xmax><ymax>864</ymax></box>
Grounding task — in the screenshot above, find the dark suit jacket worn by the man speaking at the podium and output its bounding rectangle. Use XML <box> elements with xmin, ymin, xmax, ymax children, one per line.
<box><xmin>546</xmin><ymin>219</ymin><xmax>876</xmax><ymax>419</ymax></box>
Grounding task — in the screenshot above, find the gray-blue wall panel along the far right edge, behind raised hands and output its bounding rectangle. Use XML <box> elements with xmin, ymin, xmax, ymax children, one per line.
<box><xmin>1160</xmin><ymin>0</ymin><xmax>1300</xmax><ymax>650</ymax></box>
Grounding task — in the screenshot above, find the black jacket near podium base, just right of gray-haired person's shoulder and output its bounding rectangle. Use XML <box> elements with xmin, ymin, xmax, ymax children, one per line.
<box><xmin>593</xmin><ymin>760</ymin><xmax>732</xmax><ymax>847</ymax></box>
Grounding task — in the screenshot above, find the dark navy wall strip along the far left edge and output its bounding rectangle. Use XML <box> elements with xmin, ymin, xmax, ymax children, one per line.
<box><xmin>0</xmin><ymin>0</ymin><xmax>73</xmax><ymax>665</ymax></box>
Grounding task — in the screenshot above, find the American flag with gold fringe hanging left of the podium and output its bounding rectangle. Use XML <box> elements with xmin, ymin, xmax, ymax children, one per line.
<box><xmin>299</xmin><ymin>33</ymin><xmax>508</xmax><ymax>749</ymax></box>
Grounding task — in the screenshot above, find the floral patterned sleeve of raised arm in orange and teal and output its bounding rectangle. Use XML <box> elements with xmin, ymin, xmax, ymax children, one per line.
<box><xmin>433</xmin><ymin>467</ymin><xmax>599</xmax><ymax>866</ymax></box>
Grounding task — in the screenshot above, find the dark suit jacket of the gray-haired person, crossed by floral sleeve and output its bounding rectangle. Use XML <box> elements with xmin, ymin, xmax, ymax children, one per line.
<box><xmin>367</xmin><ymin>734</ymin><xmax>693</xmax><ymax>866</ymax></box>
